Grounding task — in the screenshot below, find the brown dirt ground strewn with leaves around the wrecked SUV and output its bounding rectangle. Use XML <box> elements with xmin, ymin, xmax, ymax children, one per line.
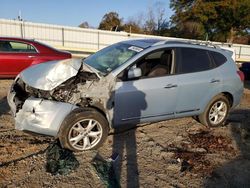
<box><xmin>0</xmin><ymin>80</ymin><xmax>250</xmax><ymax>188</ymax></box>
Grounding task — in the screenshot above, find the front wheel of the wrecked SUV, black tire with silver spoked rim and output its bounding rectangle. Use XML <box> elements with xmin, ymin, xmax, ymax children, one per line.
<box><xmin>58</xmin><ymin>109</ymin><xmax>109</xmax><ymax>151</ymax></box>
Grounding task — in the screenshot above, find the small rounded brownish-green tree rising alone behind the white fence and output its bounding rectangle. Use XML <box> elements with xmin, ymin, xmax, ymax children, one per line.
<box><xmin>98</xmin><ymin>12</ymin><xmax>122</xmax><ymax>30</ymax></box>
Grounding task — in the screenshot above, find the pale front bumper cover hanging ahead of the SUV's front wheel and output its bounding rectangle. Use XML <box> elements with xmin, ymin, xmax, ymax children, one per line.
<box><xmin>15</xmin><ymin>97</ymin><xmax>77</xmax><ymax>136</ymax></box>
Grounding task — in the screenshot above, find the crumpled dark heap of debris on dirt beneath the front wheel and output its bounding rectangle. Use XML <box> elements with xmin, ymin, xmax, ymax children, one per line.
<box><xmin>46</xmin><ymin>140</ymin><xmax>79</xmax><ymax>175</ymax></box>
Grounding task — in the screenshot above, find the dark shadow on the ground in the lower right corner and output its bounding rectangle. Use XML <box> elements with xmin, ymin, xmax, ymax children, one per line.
<box><xmin>204</xmin><ymin>109</ymin><xmax>250</xmax><ymax>188</ymax></box>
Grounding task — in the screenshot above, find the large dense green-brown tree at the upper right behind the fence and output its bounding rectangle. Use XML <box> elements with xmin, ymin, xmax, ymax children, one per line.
<box><xmin>170</xmin><ymin>0</ymin><xmax>250</xmax><ymax>42</ymax></box>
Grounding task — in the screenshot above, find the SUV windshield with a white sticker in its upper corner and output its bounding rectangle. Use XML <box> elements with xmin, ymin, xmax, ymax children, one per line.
<box><xmin>84</xmin><ymin>43</ymin><xmax>143</xmax><ymax>74</ymax></box>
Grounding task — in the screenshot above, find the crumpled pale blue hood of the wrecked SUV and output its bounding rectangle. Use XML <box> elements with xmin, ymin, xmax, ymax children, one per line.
<box><xmin>20</xmin><ymin>59</ymin><xmax>82</xmax><ymax>91</ymax></box>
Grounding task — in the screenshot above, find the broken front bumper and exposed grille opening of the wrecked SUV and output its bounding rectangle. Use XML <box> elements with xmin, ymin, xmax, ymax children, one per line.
<box><xmin>8</xmin><ymin>72</ymin><xmax>77</xmax><ymax>136</ymax></box>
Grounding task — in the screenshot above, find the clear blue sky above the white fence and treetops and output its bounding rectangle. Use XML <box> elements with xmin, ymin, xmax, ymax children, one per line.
<box><xmin>0</xmin><ymin>0</ymin><xmax>172</xmax><ymax>27</ymax></box>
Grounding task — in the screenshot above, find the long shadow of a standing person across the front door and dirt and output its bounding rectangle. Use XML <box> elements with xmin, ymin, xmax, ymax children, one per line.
<box><xmin>109</xmin><ymin>83</ymin><xmax>147</xmax><ymax>187</ymax></box>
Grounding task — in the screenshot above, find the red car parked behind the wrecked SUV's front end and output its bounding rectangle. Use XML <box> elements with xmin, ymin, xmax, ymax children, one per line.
<box><xmin>0</xmin><ymin>37</ymin><xmax>71</xmax><ymax>78</ymax></box>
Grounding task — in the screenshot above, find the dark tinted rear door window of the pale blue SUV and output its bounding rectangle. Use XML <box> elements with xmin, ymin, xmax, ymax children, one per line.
<box><xmin>176</xmin><ymin>48</ymin><xmax>214</xmax><ymax>74</ymax></box>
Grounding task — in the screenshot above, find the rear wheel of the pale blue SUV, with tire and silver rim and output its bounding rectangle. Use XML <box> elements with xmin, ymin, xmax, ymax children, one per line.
<box><xmin>198</xmin><ymin>94</ymin><xmax>230</xmax><ymax>127</ymax></box>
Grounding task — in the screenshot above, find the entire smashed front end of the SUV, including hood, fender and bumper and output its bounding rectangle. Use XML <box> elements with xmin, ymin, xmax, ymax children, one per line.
<box><xmin>8</xmin><ymin>60</ymin><xmax>114</xmax><ymax>136</ymax></box>
